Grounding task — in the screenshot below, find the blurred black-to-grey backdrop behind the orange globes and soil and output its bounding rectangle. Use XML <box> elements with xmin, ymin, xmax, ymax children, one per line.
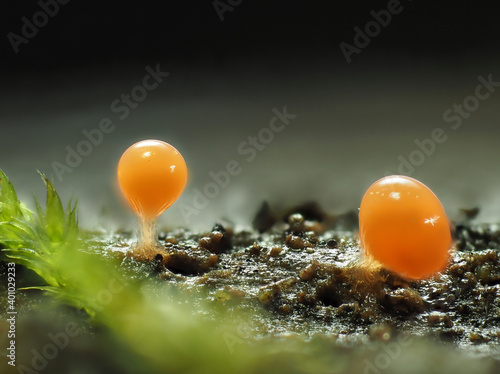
<box><xmin>0</xmin><ymin>1</ymin><xmax>500</xmax><ymax>229</ymax></box>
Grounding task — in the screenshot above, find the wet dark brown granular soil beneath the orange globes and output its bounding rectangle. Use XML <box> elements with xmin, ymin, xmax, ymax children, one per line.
<box><xmin>115</xmin><ymin>203</ymin><xmax>500</xmax><ymax>347</ymax></box>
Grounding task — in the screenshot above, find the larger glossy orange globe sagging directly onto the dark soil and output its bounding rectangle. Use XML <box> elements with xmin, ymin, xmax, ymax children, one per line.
<box><xmin>359</xmin><ymin>175</ymin><xmax>452</xmax><ymax>279</ymax></box>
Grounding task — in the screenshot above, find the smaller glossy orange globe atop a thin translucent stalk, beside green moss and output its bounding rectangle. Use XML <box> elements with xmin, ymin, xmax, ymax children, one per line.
<box><xmin>118</xmin><ymin>140</ymin><xmax>187</xmax><ymax>220</ymax></box>
